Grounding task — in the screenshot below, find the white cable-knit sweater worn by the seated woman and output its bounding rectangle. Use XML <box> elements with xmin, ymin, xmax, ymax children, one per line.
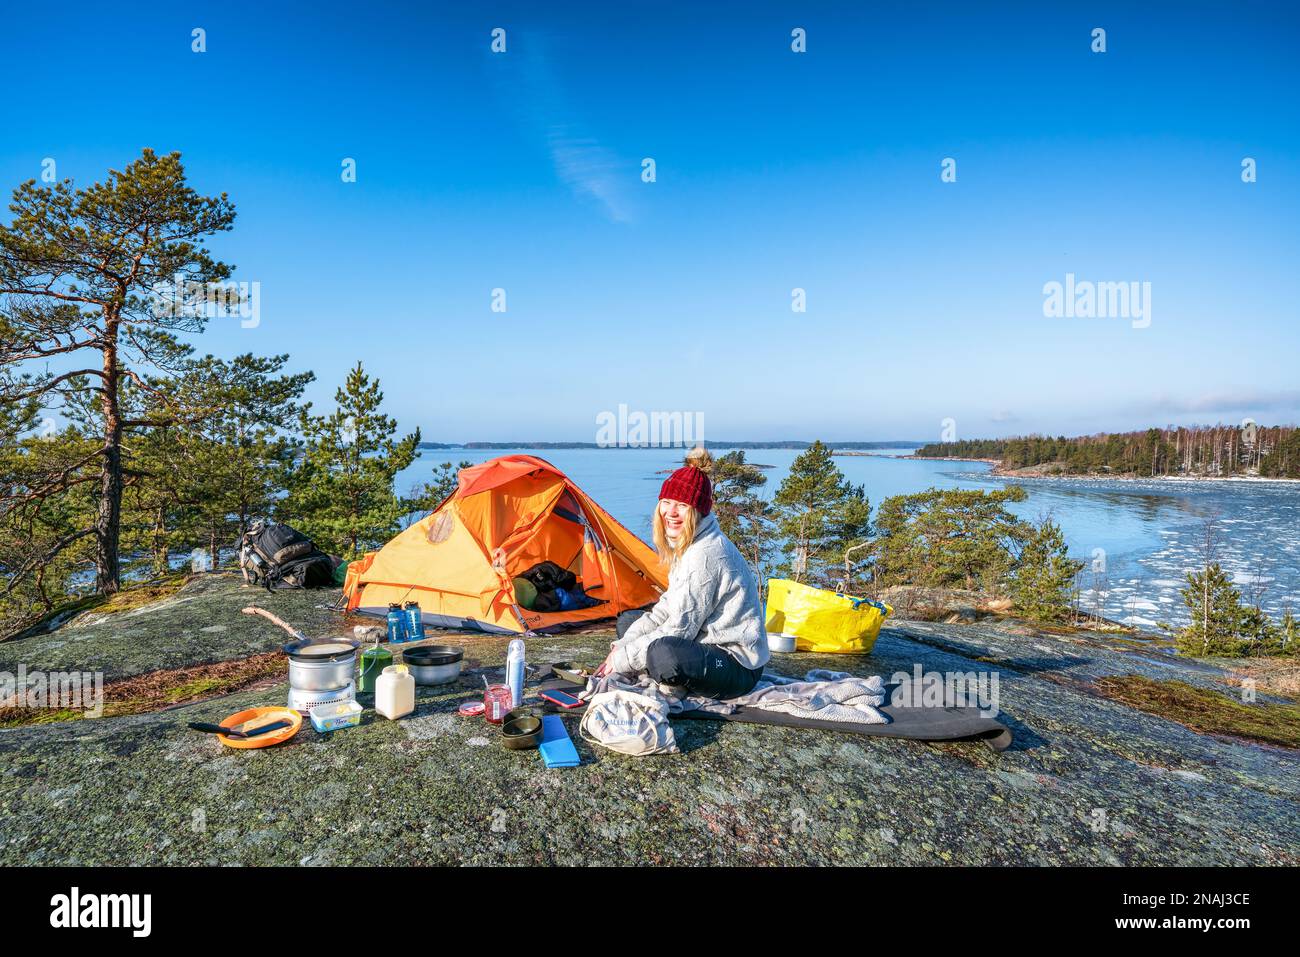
<box><xmin>611</xmin><ymin>515</ymin><xmax>771</xmax><ymax>675</ymax></box>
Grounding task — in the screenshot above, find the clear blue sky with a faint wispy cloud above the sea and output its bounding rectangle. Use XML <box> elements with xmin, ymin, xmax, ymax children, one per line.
<box><xmin>0</xmin><ymin>1</ymin><xmax>1300</xmax><ymax>441</ymax></box>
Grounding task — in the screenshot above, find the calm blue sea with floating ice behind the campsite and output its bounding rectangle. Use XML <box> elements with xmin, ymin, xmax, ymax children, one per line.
<box><xmin>397</xmin><ymin>449</ymin><xmax>1300</xmax><ymax>628</ymax></box>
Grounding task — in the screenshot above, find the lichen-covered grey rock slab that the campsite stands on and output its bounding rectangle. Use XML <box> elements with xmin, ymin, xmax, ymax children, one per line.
<box><xmin>0</xmin><ymin>576</ymin><xmax>1300</xmax><ymax>865</ymax></box>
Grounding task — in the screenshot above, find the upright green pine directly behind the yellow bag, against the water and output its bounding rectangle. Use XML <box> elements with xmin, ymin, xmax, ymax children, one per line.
<box><xmin>775</xmin><ymin>441</ymin><xmax>871</xmax><ymax>588</ymax></box>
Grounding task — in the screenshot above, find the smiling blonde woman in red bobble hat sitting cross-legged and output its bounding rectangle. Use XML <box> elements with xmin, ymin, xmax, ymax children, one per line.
<box><xmin>597</xmin><ymin>449</ymin><xmax>771</xmax><ymax>698</ymax></box>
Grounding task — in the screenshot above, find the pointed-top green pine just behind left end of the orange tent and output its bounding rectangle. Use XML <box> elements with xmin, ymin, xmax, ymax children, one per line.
<box><xmin>281</xmin><ymin>363</ymin><xmax>420</xmax><ymax>559</ymax></box>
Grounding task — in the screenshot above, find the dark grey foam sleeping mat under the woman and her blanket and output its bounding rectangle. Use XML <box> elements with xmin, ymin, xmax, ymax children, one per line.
<box><xmin>538</xmin><ymin>679</ymin><xmax>1011</xmax><ymax>752</ymax></box>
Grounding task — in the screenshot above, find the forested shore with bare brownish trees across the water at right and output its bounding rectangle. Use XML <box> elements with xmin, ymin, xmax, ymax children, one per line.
<box><xmin>913</xmin><ymin>421</ymin><xmax>1300</xmax><ymax>479</ymax></box>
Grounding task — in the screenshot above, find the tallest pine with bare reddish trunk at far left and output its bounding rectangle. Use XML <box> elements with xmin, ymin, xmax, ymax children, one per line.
<box><xmin>0</xmin><ymin>150</ymin><xmax>235</xmax><ymax>594</ymax></box>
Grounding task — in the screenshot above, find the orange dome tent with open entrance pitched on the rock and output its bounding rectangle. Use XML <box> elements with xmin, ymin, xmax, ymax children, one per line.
<box><xmin>343</xmin><ymin>455</ymin><xmax>668</xmax><ymax>633</ymax></box>
